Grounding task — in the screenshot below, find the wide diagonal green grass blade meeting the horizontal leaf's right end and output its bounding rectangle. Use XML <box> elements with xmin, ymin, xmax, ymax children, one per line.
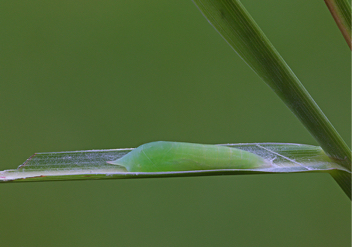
<box><xmin>193</xmin><ymin>0</ymin><xmax>351</xmax><ymax>170</ymax></box>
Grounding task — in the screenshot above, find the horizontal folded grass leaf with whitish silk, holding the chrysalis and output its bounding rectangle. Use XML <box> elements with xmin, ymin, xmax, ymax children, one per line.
<box><xmin>0</xmin><ymin>143</ymin><xmax>351</xmax><ymax>199</ymax></box>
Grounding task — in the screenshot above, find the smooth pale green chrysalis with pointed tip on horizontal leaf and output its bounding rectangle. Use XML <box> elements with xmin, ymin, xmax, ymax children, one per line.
<box><xmin>108</xmin><ymin>141</ymin><xmax>271</xmax><ymax>172</ymax></box>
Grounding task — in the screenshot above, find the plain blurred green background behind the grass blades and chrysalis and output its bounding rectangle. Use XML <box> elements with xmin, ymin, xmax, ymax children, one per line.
<box><xmin>0</xmin><ymin>0</ymin><xmax>351</xmax><ymax>247</ymax></box>
